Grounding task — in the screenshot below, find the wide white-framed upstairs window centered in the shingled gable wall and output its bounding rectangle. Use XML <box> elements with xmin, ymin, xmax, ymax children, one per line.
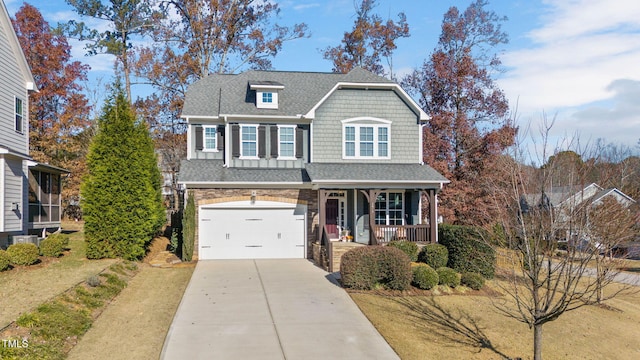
<box><xmin>343</xmin><ymin>119</ymin><xmax>390</xmax><ymax>159</ymax></box>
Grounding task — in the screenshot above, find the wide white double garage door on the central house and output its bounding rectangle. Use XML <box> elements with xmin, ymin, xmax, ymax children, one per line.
<box><xmin>199</xmin><ymin>208</ymin><xmax>306</xmax><ymax>260</ymax></box>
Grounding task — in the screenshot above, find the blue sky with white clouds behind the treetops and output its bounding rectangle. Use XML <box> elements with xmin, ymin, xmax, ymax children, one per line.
<box><xmin>4</xmin><ymin>0</ymin><xmax>640</xmax><ymax>158</ymax></box>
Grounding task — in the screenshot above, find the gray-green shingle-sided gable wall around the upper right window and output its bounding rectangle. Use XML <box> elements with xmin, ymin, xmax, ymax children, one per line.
<box><xmin>312</xmin><ymin>89</ymin><xmax>420</xmax><ymax>164</ymax></box>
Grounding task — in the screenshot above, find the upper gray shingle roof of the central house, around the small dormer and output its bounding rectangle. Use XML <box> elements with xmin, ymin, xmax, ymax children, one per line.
<box><xmin>182</xmin><ymin>67</ymin><xmax>428</xmax><ymax>120</ymax></box>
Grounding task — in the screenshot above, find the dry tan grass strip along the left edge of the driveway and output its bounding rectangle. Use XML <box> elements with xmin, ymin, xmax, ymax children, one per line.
<box><xmin>69</xmin><ymin>265</ymin><xmax>194</xmax><ymax>360</ymax></box>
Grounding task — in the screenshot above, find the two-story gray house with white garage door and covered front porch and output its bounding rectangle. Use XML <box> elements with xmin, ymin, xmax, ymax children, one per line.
<box><xmin>179</xmin><ymin>68</ymin><xmax>449</xmax><ymax>266</ymax></box>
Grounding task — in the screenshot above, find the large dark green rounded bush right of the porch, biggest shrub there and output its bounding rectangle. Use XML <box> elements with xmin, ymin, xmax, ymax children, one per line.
<box><xmin>438</xmin><ymin>224</ymin><xmax>496</xmax><ymax>279</ymax></box>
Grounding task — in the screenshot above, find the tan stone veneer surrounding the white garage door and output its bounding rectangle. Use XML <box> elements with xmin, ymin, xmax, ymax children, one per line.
<box><xmin>189</xmin><ymin>189</ymin><xmax>319</xmax><ymax>260</ymax></box>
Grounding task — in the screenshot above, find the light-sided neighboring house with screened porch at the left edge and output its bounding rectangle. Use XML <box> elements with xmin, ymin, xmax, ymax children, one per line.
<box><xmin>0</xmin><ymin>0</ymin><xmax>67</xmax><ymax>247</ymax></box>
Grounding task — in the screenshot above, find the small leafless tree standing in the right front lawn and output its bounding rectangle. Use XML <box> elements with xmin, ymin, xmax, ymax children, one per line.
<box><xmin>493</xmin><ymin>120</ymin><xmax>633</xmax><ymax>360</ymax></box>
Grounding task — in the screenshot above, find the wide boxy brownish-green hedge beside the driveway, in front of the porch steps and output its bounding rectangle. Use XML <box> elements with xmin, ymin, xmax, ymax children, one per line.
<box><xmin>340</xmin><ymin>246</ymin><xmax>413</xmax><ymax>290</ymax></box>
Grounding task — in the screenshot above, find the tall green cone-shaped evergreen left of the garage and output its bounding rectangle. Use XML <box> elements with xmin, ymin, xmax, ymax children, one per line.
<box><xmin>81</xmin><ymin>84</ymin><xmax>164</xmax><ymax>260</ymax></box>
